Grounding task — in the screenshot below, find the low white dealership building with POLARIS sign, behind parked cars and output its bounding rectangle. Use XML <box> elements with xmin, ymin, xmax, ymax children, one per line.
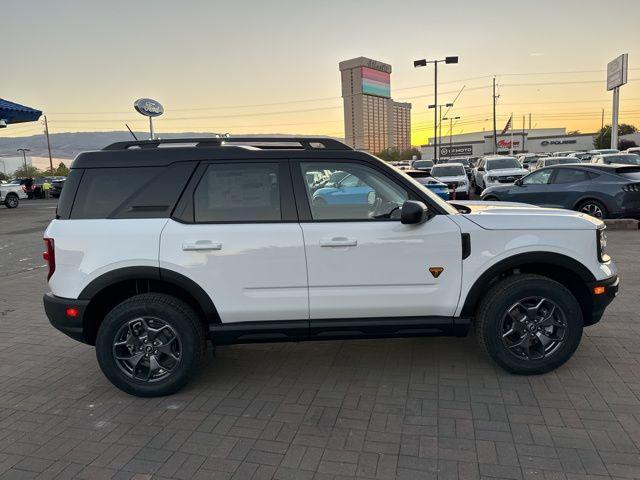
<box><xmin>420</xmin><ymin>128</ymin><xmax>595</xmax><ymax>159</ymax></box>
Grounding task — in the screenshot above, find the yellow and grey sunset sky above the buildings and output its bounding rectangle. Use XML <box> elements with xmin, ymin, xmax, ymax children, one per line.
<box><xmin>5</xmin><ymin>0</ymin><xmax>640</xmax><ymax>144</ymax></box>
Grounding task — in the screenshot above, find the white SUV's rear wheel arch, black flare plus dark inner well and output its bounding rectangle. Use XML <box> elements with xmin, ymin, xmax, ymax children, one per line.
<box><xmin>78</xmin><ymin>267</ymin><xmax>220</xmax><ymax>345</ymax></box>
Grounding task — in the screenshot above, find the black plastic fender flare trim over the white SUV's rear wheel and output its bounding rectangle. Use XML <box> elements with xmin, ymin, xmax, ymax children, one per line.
<box><xmin>78</xmin><ymin>267</ymin><xmax>220</xmax><ymax>322</ymax></box>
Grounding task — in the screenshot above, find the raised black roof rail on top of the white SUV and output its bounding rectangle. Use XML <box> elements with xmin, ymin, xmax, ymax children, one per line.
<box><xmin>102</xmin><ymin>137</ymin><xmax>352</xmax><ymax>150</ymax></box>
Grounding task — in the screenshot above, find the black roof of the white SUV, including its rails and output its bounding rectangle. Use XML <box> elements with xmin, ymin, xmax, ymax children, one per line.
<box><xmin>72</xmin><ymin>136</ymin><xmax>373</xmax><ymax>168</ymax></box>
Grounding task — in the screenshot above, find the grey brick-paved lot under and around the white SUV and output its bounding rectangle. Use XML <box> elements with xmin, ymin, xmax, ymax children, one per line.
<box><xmin>0</xmin><ymin>200</ymin><xmax>640</xmax><ymax>480</ymax></box>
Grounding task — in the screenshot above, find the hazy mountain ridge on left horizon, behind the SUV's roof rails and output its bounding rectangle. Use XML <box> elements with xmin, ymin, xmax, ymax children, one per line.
<box><xmin>0</xmin><ymin>130</ymin><xmax>342</xmax><ymax>158</ymax></box>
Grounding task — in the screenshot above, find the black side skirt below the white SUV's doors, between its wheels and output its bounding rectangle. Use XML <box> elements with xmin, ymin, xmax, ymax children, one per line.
<box><xmin>209</xmin><ymin>317</ymin><xmax>471</xmax><ymax>345</ymax></box>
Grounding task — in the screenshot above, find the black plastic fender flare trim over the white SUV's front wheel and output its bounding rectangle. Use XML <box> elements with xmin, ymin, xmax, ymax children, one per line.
<box><xmin>460</xmin><ymin>252</ymin><xmax>596</xmax><ymax>317</ymax></box>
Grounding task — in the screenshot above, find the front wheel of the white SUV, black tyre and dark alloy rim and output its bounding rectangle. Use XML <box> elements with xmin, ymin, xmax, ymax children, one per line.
<box><xmin>475</xmin><ymin>274</ymin><xmax>583</xmax><ymax>375</ymax></box>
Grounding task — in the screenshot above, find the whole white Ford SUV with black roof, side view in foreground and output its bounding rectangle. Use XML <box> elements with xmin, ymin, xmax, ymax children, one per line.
<box><xmin>44</xmin><ymin>137</ymin><xmax>618</xmax><ymax>396</ymax></box>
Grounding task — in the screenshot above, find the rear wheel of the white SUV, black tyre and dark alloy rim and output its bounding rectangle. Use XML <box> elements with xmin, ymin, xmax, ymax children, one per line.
<box><xmin>96</xmin><ymin>293</ymin><xmax>205</xmax><ymax>397</ymax></box>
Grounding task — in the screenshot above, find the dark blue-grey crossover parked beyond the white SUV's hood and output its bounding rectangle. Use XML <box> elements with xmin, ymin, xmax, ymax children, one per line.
<box><xmin>482</xmin><ymin>164</ymin><xmax>640</xmax><ymax>218</ymax></box>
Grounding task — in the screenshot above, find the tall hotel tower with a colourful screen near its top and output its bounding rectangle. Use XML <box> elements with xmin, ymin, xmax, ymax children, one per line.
<box><xmin>338</xmin><ymin>57</ymin><xmax>411</xmax><ymax>153</ymax></box>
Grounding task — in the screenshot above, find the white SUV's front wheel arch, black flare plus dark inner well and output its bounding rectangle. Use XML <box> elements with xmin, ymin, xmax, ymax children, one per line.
<box><xmin>460</xmin><ymin>252</ymin><xmax>596</xmax><ymax>325</ymax></box>
